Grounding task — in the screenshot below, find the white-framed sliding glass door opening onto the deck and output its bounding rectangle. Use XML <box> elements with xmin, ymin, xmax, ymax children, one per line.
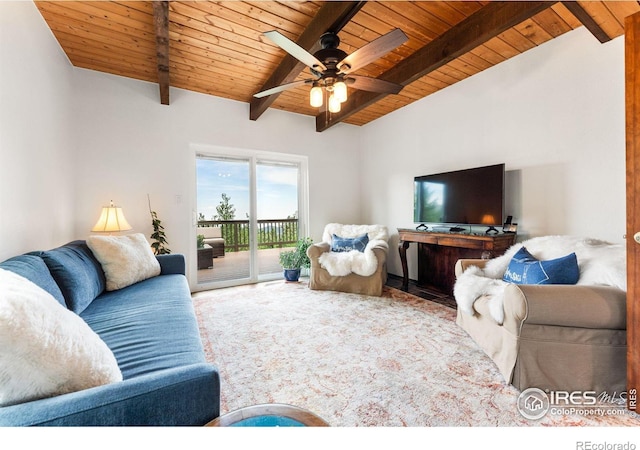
<box><xmin>196</xmin><ymin>146</ymin><xmax>307</xmax><ymax>289</ymax></box>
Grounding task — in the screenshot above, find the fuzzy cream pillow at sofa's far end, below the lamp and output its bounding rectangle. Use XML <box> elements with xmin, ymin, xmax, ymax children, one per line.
<box><xmin>87</xmin><ymin>233</ymin><xmax>160</xmax><ymax>291</ymax></box>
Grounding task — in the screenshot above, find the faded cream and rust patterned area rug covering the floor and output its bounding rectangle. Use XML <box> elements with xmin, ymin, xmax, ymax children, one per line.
<box><xmin>193</xmin><ymin>281</ymin><xmax>640</xmax><ymax>427</ymax></box>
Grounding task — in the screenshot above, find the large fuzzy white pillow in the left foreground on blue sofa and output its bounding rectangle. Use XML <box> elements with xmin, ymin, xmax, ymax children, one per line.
<box><xmin>0</xmin><ymin>269</ymin><xmax>122</xmax><ymax>406</ymax></box>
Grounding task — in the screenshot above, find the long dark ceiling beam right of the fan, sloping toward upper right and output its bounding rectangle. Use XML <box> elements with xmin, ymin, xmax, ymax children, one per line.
<box><xmin>316</xmin><ymin>1</ymin><xmax>557</xmax><ymax>132</ymax></box>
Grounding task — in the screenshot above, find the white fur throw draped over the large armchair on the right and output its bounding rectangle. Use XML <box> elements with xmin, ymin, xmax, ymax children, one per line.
<box><xmin>453</xmin><ymin>236</ymin><xmax>627</xmax><ymax>324</ymax></box>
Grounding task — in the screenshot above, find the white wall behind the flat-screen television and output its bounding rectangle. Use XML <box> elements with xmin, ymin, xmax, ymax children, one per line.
<box><xmin>360</xmin><ymin>28</ymin><xmax>625</xmax><ymax>278</ymax></box>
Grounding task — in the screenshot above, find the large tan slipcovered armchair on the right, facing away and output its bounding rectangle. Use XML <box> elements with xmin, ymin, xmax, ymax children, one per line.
<box><xmin>454</xmin><ymin>236</ymin><xmax>627</xmax><ymax>395</ymax></box>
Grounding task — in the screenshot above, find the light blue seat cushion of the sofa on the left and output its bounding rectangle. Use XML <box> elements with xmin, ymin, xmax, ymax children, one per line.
<box><xmin>81</xmin><ymin>275</ymin><xmax>205</xmax><ymax>379</ymax></box>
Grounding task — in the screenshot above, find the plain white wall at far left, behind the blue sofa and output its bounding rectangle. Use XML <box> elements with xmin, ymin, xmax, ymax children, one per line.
<box><xmin>0</xmin><ymin>2</ymin><xmax>76</xmax><ymax>261</ymax></box>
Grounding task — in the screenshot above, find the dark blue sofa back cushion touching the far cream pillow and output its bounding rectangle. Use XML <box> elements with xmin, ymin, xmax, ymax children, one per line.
<box><xmin>41</xmin><ymin>241</ymin><xmax>106</xmax><ymax>314</ymax></box>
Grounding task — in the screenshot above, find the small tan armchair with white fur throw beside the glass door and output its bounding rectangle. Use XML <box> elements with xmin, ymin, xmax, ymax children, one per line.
<box><xmin>307</xmin><ymin>223</ymin><xmax>389</xmax><ymax>296</ymax></box>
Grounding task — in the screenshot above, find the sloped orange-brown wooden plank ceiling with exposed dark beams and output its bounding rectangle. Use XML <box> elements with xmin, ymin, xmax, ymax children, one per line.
<box><xmin>36</xmin><ymin>1</ymin><xmax>640</xmax><ymax>131</ymax></box>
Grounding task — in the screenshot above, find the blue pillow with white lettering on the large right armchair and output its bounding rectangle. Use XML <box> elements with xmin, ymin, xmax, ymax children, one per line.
<box><xmin>502</xmin><ymin>247</ymin><xmax>580</xmax><ymax>284</ymax></box>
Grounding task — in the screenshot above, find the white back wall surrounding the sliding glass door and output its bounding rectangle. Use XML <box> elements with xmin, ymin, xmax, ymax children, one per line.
<box><xmin>73</xmin><ymin>69</ymin><xmax>361</xmax><ymax>284</ymax></box>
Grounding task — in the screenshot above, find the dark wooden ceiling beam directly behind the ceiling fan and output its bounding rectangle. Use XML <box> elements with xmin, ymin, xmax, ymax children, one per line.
<box><xmin>249</xmin><ymin>1</ymin><xmax>366</xmax><ymax>120</ymax></box>
